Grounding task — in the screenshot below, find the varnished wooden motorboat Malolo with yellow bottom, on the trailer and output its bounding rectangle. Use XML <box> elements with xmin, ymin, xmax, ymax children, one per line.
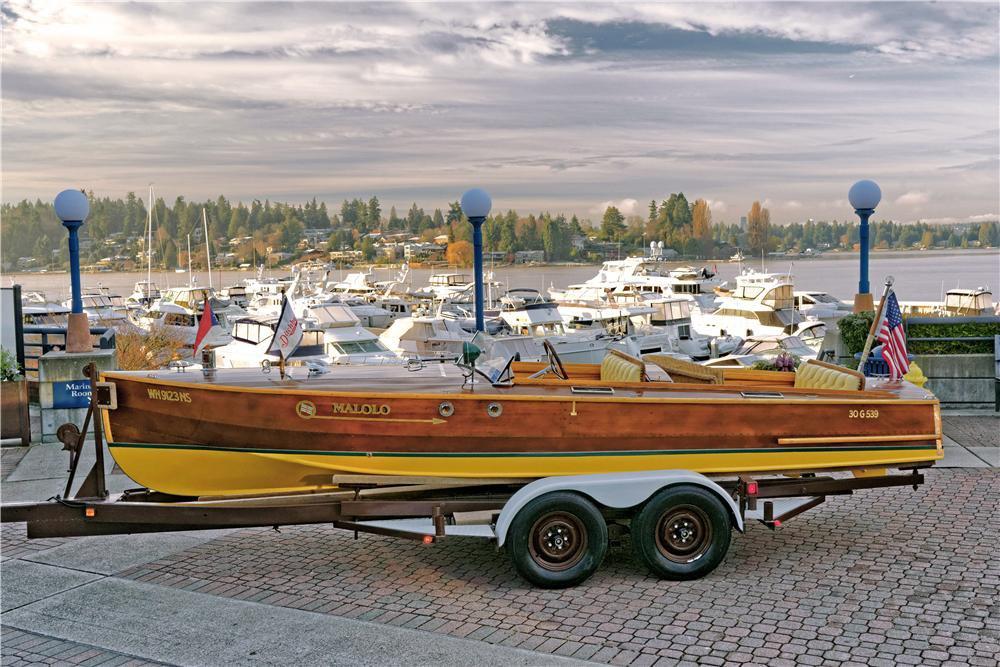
<box><xmin>101</xmin><ymin>354</ymin><xmax>943</xmax><ymax>496</ymax></box>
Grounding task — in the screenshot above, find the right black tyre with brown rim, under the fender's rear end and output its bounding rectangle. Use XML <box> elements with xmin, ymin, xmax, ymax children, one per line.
<box><xmin>632</xmin><ymin>485</ymin><xmax>731</xmax><ymax>580</ymax></box>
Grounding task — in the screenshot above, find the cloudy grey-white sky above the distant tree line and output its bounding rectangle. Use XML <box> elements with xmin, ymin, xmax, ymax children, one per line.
<box><xmin>2</xmin><ymin>0</ymin><xmax>1000</xmax><ymax>222</ymax></box>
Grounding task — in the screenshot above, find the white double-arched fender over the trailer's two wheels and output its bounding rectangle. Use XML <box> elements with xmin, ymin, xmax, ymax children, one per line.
<box><xmin>494</xmin><ymin>470</ymin><xmax>743</xmax><ymax>546</ymax></box>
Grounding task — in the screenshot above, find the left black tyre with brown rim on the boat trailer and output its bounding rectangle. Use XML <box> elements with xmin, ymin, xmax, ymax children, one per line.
<box><xmin>507</xmin><ymin>491</ymin><xmax>608</xmax><ymax>588</ymax></box>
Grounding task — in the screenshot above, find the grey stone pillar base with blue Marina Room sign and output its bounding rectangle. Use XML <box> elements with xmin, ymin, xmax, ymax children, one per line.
<box><xmin>38</xmin><ymin>350</ymin><xmax>117</xmax><ymax>442</ymax></box>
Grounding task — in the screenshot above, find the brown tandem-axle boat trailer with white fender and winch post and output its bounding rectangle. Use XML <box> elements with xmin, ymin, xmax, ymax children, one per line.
<box><xmin>0</xmin><ymin>366</ymin><xmax>924</xmax><ymax>587</ymax></box>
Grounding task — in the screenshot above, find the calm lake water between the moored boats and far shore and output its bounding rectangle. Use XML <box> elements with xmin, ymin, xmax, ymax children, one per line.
<box><xmin>4</xmin><ymin>249</ymin><xmax>1000</xmax><ymax>301</ymax></box>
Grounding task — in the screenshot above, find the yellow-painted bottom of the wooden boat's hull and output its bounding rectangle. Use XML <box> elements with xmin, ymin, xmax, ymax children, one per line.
<box><xmin>110</xmin><ymin>443</ymin><xmax>943</xmax><ymax>496</ymax></box>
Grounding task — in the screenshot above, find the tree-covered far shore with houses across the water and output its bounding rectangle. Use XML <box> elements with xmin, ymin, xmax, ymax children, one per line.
<box><xmin>0</xmin><ymin>193</ymin><xmax>1000</xmax><ymax>268</ymax></box>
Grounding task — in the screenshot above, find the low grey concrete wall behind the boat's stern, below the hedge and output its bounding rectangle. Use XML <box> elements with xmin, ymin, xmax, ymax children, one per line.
<box><xmin>913</xmin><ymin>354</ymin><xmax>996</xmax><ymax>409</ymax></box>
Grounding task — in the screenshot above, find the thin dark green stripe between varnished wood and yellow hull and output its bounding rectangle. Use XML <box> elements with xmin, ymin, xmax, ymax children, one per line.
<box><xmin>108</xmin><ymin>442</ymin><xmax>937</xmax><ymax>458</ymax></box>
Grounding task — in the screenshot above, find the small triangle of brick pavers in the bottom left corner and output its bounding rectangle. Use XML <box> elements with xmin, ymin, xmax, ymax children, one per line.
<box><xmin>0</xmin><ymin>625</ymin><xmax>163</xmax><ymax>667</ymax></box>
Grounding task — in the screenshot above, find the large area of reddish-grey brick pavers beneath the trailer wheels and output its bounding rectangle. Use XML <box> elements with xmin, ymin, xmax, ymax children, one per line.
<box><xmin>103</xmin><ymin>469</ymin><xmax>1000</xmax><ymax>667</ymax></box>
